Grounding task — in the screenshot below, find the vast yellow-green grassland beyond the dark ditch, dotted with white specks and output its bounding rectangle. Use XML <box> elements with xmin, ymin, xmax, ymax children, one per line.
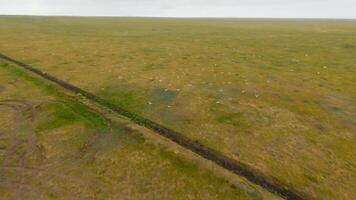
<box><xmin>0</xmin><ymin>16</ymin><xmax>356</xmax><ymax>199</ymax></box>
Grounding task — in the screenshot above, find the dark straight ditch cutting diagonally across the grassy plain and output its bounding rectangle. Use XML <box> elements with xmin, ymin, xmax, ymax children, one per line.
<box><xmin>0</xmin><ymin>53</ymin><xmax>311</xmax><ymax>200</ymax></box>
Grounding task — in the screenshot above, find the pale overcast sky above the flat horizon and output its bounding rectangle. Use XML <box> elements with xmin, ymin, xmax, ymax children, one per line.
<box><xmin>0</xmin><ymin>0</ymin><xmax>356</xmax><ymax>19</ymax></box>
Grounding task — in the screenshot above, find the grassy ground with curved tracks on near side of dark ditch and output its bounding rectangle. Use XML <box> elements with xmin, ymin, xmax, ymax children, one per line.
<box><xmin>0</xmin><ymin>62</ymin><xmax>278</xmax><ymax>200</ymax></box>
